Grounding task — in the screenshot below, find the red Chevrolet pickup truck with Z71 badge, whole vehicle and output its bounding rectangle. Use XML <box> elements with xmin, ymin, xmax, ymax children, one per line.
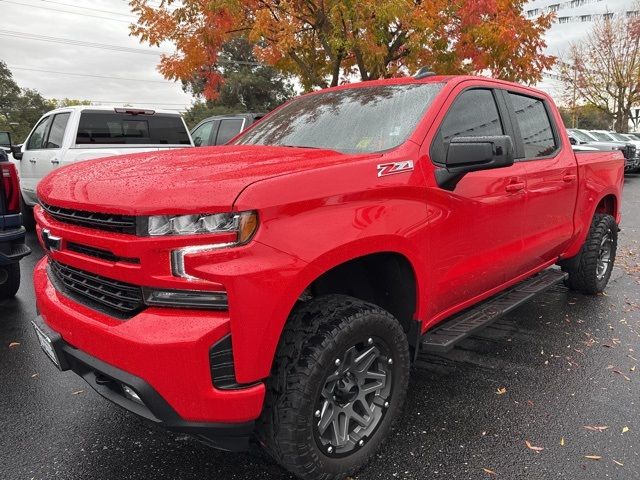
<box><xmin>34</xmin><ymin>75</ymin><xmax>624</xmax><ymax>479</ymax></box>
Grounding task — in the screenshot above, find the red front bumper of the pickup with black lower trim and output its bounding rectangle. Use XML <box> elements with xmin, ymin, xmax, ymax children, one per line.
<box><xmin>34</xmin><ymin>258</ymin><xmax>264</xmax><ymax>442</ymax></box>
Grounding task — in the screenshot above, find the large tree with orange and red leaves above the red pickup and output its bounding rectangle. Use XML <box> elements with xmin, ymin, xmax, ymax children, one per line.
<box><xmin>130</xmin><ymin>0</ymin><xmax>554</xmax><ymax>98</ymax></box>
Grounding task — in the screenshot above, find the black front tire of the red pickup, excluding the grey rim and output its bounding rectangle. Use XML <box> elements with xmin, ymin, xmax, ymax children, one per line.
<box><xmin>256</xmin><ymin>295</ymin><xmax>410</xmax><ymax>480</ymax></box>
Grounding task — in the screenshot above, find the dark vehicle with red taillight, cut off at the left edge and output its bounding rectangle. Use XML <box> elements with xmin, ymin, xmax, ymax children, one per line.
<box><xmin>0</xmin><ymin>132</ymin><xmax>31</xmax><ymax>300</ymax></box>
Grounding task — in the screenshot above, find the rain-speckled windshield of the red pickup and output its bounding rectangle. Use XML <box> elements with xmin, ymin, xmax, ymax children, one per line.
<box><xmin>234</xmin><ymin>83</ymin><xmax>443</xmax><ymax>153</ymax></box>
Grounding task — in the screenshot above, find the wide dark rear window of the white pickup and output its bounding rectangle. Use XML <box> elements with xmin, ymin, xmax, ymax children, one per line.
<box><xmin>76</xmin><ymin>110</ymin><xmax>190</xmax><ymax>145</ymax></box>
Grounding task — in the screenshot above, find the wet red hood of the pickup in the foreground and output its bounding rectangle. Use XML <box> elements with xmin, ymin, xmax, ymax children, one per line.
<box><xmin>38</xmin><ymin>145</ymin><xmax>379</xmax><ymax>215</ymax></box>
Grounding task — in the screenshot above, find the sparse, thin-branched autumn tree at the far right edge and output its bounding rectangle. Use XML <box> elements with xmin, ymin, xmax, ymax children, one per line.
<box><xmin>559</xmin><ymin>14</ymin><xmax>640</xmax><ymax>132</ymax></box>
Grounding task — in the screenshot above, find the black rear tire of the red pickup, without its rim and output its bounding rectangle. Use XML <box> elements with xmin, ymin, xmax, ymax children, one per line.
<box><xmin>562</xmin><ymin>213</ymin><xmax>618</xmax><ymax>295</ymax></box>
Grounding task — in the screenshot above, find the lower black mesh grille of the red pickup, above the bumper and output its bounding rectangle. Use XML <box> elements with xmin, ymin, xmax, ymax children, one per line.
<box><xmin>49</xmin><ymin>260</ymin><xmax>145</xmax><ymax>319</ymax></box>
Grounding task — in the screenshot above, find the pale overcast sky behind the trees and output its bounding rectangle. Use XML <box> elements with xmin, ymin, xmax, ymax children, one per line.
<box><xmin>0</xmin><ymin>0</ymin><xmax>634</xmax><ymax>111</ymax></box>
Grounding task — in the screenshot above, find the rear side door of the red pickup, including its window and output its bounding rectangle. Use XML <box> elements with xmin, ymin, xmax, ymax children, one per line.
<box><xmin>505</xmin><ymin>91</ymin><xmax>578</xmax><ymax>270</ymax></box>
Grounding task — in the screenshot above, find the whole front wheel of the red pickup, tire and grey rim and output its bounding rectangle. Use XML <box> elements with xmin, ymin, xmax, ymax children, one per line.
<box><xmin>258</xmin><ymin>295</ymin><xmax>410</xmax><ymax>480</ymax></box>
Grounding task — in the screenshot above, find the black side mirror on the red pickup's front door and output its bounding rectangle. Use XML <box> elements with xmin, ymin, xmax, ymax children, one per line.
<box><xmin>436</xmin><ymin>135</ymin><xmax>513</xmax><ymax>190</ymax></box>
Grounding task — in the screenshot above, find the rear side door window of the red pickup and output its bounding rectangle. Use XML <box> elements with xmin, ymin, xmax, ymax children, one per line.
<box><xmin>508</xmin><ymin>92</ymin><xmax>558</xmax><ymax>158</ymax></box>
